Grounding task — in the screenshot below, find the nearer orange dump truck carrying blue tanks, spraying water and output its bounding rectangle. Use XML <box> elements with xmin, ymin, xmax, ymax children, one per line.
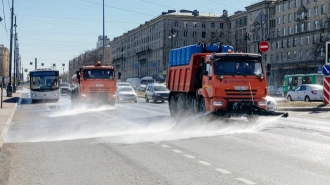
<box><xmin>167</xmin><ymin>44</ymin><xmax>288</xmax><ymax>122</ymax></box>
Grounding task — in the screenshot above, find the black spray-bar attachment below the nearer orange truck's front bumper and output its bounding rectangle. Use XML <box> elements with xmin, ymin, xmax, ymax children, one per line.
<box><xmin>216</xmin><ymin>101</ymin><xmax>289</xmax><ymax>118</ymax></box>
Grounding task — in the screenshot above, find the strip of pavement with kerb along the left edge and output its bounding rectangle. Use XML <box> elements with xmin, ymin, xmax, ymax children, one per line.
<box><xmin>0</xmin><ymin>88</ymin><xmax>21</xmax><ymax>151</ymax></box>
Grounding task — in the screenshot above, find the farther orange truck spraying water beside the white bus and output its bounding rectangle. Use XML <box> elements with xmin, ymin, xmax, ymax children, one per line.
<box><xmin>71</xmin><ymin>62</ymin><xmax>116</xmax><ymax>105</ymax></box>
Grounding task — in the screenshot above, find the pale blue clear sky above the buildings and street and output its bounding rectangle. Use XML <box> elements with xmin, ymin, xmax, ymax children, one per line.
<box><xmin>0</xmin><ymin>0</ymin><xmax>255</xmax><ymax>72</ymax></box>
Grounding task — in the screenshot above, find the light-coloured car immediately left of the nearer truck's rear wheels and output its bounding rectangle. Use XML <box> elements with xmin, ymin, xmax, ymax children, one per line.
<box><xmin>145</xmin><ymin>83</ymin><xmax>170</xmax><ymax>103</ymax></box>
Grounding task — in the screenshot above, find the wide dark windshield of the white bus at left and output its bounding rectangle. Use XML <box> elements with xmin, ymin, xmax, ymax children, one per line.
<box><xmin>30</xmin><ymin>71</ymin><xmax>59</xmax><ymax>91</ymax></box>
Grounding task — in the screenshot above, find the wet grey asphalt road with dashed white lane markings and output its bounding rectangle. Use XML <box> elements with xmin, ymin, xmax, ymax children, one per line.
<box><xmin>0</xmin><ymin>90</ymin><xmax>330</xmax><ymax>185</ymax></box>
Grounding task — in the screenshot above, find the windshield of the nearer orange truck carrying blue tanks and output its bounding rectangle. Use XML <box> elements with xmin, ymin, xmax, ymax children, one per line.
<box><xmin>214</xmin><ymin>60</ymin><xmax>263</xmax><ymax>75</ymax></box>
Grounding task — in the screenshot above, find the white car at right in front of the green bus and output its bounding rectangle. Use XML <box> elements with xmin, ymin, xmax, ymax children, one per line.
<box><xmin>286</xmin><ymin>84</ymin><xmax>323</xmax><ymax>102</ymax></box>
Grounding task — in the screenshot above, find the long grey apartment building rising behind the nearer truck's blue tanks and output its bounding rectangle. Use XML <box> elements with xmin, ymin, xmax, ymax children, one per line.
<box><xmin>110</xmin><ymin>10</ymin><xmax>229</xmax><ymax>80</ymax></box>
